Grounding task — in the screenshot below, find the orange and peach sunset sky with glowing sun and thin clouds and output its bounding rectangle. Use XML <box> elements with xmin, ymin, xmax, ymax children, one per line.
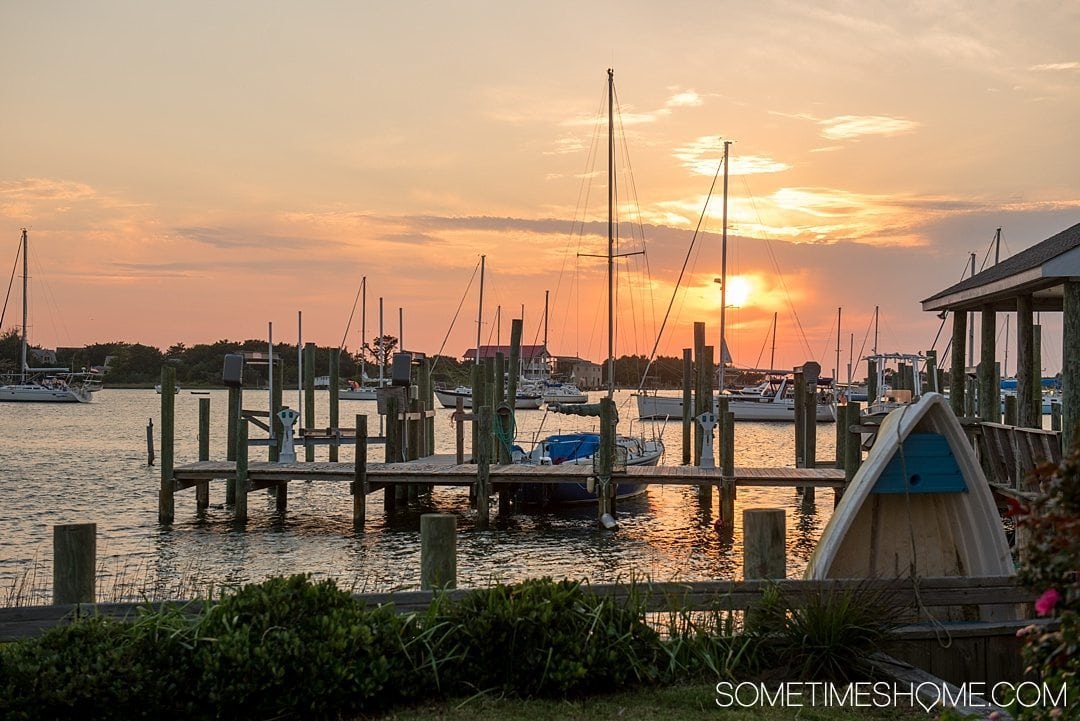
<box><xmin>0</xmin><ymin>0</ymin><xmax>1080</xmax><ymax>372</ymax></box>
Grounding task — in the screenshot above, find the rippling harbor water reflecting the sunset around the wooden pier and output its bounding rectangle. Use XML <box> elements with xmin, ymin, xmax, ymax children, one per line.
<box><xmin>0</xmin><ymin>389</ymin><xmax>835</xmax><ymax>603</ymax></box>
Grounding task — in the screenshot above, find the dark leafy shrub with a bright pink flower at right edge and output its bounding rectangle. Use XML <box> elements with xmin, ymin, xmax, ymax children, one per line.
<box><xmin>1010</xmin><ymin>445</ymin><xmax>1080</xmax><ymax>719</ymax></box>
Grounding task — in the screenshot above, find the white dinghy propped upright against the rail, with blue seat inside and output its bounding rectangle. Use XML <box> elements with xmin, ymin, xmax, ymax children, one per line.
<box><xmin>806</xmin><ymin>393</ymin><xmax>1015</xmax><ymax>620</ymax></box>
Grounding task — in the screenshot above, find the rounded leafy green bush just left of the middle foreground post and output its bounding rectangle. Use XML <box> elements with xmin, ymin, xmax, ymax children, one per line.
<box><xmin>194</xmin><ymin>575</ymin><xmax>404</xmax><ymax>718</ymax></box>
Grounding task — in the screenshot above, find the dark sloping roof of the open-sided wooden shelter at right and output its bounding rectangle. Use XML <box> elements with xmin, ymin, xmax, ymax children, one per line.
<box><xmin>922</xmin><ymin>223</ymin><xmax>1080</xmax><ymax>311</ymax></box>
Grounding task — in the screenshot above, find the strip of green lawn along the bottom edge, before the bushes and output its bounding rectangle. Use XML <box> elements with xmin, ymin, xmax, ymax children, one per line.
<box><xmin>355</xmin><ymin>683</ymin><xmax>929</xmax><ymax>721</ymax></box>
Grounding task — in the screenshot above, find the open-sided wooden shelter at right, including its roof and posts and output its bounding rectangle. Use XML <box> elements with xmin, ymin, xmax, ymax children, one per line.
<box><xmin>922</xmin><ymin>223</ymin><xmax>1080</xmax><ymax>449</ymax></box>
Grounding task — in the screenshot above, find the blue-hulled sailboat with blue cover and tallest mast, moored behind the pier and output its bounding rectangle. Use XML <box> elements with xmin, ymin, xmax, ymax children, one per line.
<box><xmin>518</xmin><ymin>69</ymin><xmax>664</xmax><ymax>505</ymax></box>
